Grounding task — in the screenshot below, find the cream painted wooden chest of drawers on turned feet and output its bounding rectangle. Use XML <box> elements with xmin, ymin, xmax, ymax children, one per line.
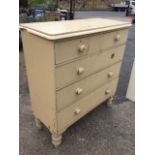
<box><xmin>20</xmin><ymin>18</ymin><xmax>131</xmax><ymax>146</ymax></box>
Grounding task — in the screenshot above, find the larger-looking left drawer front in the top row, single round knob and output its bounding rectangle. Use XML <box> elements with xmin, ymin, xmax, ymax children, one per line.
<box><xmin>55</xmin><ymin>35</ymin><xmax>100</xmax><ymax>64</ymax></box>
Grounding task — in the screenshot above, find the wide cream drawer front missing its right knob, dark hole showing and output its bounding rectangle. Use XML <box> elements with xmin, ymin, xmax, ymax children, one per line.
<box><xmin>56</xmin><ymin>46</ymin><xmax>125</xmax><ymax>90</ymax></box>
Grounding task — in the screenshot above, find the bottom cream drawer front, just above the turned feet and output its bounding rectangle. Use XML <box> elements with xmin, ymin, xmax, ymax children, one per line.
<box><xmin>57</xmin><ymin>79</ymin><xmax>118</xmax><ymax>132</ymax></box>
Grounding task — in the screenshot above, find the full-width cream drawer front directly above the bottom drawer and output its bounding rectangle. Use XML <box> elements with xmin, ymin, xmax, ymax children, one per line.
<box><xmin>56</xmin><ymin>62</ymin><xmax>121</xmax><ymax>111</ymax></box>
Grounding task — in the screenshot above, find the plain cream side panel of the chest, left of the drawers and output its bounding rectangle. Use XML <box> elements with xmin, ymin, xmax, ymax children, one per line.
<box><xmin>22</xmin><ymin>30</ymin><xmax>57</xmax><ymax>133</ymax></box>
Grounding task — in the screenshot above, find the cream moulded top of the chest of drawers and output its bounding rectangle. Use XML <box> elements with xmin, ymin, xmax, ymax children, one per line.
<box><xmin>20</xmin><ymin>18</ymin><xmax>131</xmax><ymax>40</ymax></box>
